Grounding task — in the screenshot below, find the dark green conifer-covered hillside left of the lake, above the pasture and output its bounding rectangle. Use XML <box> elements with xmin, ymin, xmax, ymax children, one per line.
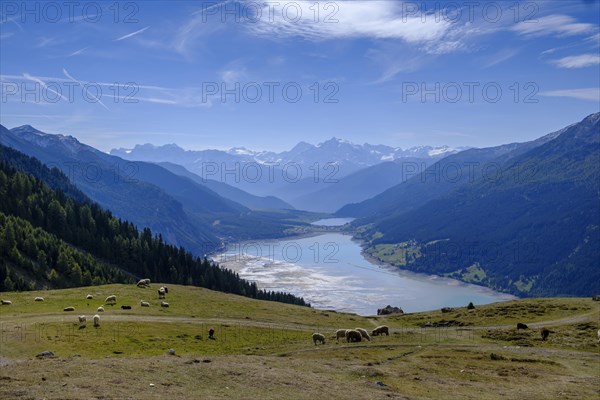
<box><xmin>0</xmin><ymin>147</ymin><xmax>305</xmax><ymax>305</ymax></box>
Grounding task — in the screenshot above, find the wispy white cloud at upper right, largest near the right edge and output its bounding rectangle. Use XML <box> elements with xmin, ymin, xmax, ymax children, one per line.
<box><xmin>511</xmin><ymin>14</ymin><xmax>598</xmax><ymax>36</ymax></box>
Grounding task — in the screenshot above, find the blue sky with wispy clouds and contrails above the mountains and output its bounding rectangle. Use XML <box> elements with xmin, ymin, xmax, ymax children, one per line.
<box><xmin>0</xmin><ymin>0</ymin><xmax>600</xmax><ymax>150</ymax></box>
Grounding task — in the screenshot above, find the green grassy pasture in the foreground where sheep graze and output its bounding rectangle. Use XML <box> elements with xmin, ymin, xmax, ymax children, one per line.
<box><xmin>0</xmin><ymin>284</ymin><xmax>600</xmax><ymax>400</ymax></box>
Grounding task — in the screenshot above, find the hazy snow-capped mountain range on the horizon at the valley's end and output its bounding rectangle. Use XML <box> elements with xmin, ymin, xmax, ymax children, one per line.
<box><xmin>110</xmin><ymin>138</ymin><xmax>465</xmax><ymax>212</ymax></box>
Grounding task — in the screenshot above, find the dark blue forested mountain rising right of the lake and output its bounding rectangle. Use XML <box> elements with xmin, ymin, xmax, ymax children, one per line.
<box><xmin>352</xmin><ymin>113</ymin><xmax>600</xmax><ymax>296</ymax></box>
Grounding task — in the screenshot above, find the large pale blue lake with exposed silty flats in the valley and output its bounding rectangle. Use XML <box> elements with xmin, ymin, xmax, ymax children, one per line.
<box><xmin>213</xmin><ymin>232</ymin><xmax>514</xmax><ymax>315</ymax></box>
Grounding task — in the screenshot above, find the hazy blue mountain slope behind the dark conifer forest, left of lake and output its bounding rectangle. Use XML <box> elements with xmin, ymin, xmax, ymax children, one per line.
<box><xmin>0</xmin><ymin>125</ymin><xmax>314</xmax><ymax>254</ymax></box>
